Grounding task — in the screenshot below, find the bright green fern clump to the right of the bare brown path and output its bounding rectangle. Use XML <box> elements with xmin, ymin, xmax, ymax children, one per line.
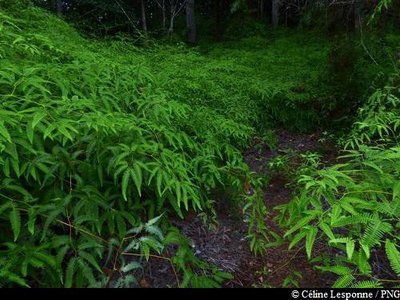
<box><xmin>278</xmin><ymin>68</ymin><xmax>400</xmax><ymax>288</ymax></box>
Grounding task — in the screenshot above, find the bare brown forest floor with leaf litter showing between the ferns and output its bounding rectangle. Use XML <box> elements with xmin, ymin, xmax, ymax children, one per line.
<box><xmin>140</xmin><ymin>130</ymin><xmax>336</xmax><ymax>288</ymax></box>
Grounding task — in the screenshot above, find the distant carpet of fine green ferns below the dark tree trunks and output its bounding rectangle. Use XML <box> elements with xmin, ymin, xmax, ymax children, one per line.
<box><xmin>150</xmin><ymin>31</ymin><xmax>329</xmax><ymax>135</ymax></box>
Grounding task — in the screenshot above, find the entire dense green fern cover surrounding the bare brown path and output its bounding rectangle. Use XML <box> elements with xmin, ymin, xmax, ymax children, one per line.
<box><xmin>0</xmin><ymin>1</ymin><xmax>400</xmax><ymax>287</ymax></box>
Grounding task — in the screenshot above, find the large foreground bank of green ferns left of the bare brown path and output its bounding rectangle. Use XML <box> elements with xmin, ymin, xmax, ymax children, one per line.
<box><xmin>0</xmin><ymin>2</ymin><xmax>265</xmax><ymax>287</ymax></box>
